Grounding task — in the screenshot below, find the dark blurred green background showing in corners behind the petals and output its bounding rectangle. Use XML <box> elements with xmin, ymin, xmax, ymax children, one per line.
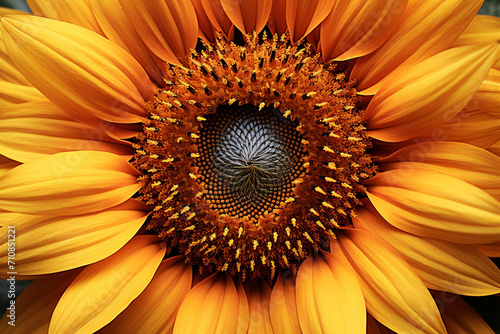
<box><xmin>0</xmin><ymin>0</ymin><xmax>500</xmax><ymax>334</ymax></box>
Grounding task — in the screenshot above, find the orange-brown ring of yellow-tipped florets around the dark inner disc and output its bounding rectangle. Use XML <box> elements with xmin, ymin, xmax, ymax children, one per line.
<box><xmin>134</xmin><ymin>35</ymin><xmax>374</xmax><ymax>279</ymax></box>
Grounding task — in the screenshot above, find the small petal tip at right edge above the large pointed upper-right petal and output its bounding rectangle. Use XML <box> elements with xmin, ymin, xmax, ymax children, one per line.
<box><xmin>453</xmin><ymin>15</ymin><xmax>500</xmax><ymax>47</ymax></box>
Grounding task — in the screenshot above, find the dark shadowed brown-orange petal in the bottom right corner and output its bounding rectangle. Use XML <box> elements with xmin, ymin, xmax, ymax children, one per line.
<box><xmin>432</xmin><ymin>291</ymin><xmax>494</xmax><ymax>334</ymax></box>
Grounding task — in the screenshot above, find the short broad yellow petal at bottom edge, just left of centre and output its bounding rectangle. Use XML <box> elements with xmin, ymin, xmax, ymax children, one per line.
<box><xmin>174</xmin><ymin>273</ymin><xmax>239</xmax><ymax>334</ymax></box>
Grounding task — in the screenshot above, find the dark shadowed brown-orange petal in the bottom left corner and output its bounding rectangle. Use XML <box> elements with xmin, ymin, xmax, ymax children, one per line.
<box><xmin>0</xmin><ymin>269</ymin><xmax>81</xmax><ymax>334</ymax></box>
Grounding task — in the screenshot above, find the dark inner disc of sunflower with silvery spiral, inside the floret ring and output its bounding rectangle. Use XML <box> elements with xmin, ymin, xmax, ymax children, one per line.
<box><xmin>196</xmin><ymin>104</ymin><xmax>305</xmax><ymax>222</ymax></box>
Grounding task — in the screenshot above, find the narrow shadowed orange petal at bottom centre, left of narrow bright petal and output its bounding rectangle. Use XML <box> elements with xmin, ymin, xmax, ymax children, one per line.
<box><xmin>245</xmin><ymin>281</ymin><xmax>273</xmax><ymax>334</ymax></box>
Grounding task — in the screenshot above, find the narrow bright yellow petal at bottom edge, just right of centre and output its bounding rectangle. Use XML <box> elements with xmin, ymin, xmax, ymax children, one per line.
<box><xmin>269</xmin><ymin>273</ymin><xmax>302</xmax><ymax>334</ymax></box>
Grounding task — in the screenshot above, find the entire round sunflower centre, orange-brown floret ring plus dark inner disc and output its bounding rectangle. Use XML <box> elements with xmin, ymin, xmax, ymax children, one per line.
<box><xmin>133</xmin><ymin>35</ymin><xmax>375</xmax><ymax>280</ymax></box>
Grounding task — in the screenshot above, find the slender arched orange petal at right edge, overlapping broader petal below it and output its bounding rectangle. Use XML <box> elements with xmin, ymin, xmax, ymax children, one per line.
<box><xmin>378</xmin><ymin>141</ymin><xmax>500</xmax><ymax>200</ymax></box>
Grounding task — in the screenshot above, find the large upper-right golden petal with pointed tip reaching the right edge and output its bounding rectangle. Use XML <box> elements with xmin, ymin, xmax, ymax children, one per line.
<box><xmin>364</xmin><ymin>44</ymin><xmax>498</xmax><ymax>142</ymax></box>
